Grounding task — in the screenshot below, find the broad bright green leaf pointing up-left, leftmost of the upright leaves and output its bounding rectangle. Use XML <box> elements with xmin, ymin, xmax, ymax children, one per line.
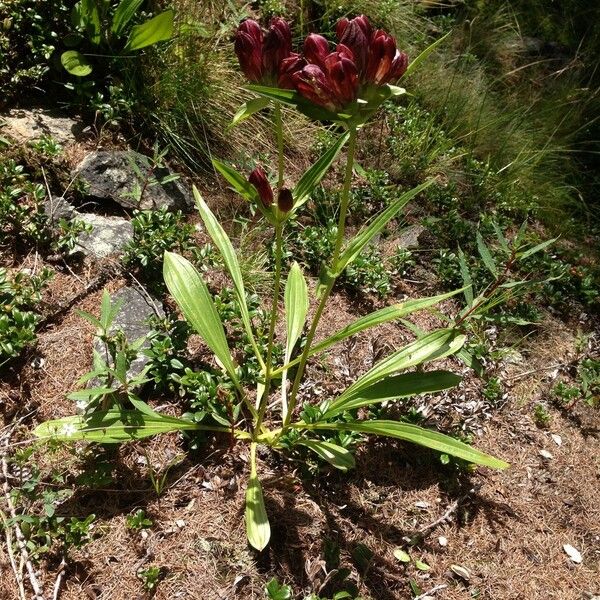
<box><xmin>163</xmin><ymin>252</ymin><xmax>239</xmax><ymax>384</ymax></box>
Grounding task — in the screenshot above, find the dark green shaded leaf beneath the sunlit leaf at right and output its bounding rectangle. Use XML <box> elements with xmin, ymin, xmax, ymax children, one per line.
<box><xmin>323</xmin><ymin>371</ymin><xmax>462</xmax><ymax>419</ymax></box>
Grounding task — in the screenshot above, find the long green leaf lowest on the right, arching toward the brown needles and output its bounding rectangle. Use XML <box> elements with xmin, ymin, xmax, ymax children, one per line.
<box><xmin>307</xmin><ymin>419</ymin><xmax>509</xmax><ymax>469</ymax></box>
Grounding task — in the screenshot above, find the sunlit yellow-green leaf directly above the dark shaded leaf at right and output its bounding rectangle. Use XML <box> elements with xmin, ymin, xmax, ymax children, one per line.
<box><xmin>336</xmin><ymin>329</ymin><xmax>466</xmax><ymax>404</ymax></box>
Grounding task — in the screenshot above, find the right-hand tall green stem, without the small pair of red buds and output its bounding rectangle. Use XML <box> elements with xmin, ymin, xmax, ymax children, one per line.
<box><xmin>282</xmin><ymin>128</ymin><xmax>357</xmax><ymax>432</ymax></box>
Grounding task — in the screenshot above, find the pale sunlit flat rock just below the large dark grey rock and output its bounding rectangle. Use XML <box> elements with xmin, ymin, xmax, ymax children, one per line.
<box><xmin>74</xmin><ymin>213</ymin><xmax>133</xmax><ymax>258</ymax></box>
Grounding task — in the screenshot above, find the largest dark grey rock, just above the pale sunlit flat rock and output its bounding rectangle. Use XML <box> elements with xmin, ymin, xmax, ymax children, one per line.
<box><xmin>76</xmin><ymin>150</ymin><xmax>193</xmax><ymax>210</ymax></box>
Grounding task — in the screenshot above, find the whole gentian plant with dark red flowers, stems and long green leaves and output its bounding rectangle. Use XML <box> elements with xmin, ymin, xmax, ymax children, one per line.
<box><xmin>36</xmin><ymin>16</ymin><xmax>508</xmax><ymax>550</ymax></box>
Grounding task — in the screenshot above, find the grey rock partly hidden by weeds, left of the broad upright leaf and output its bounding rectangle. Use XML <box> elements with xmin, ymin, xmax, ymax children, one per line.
<box><xmin>91</xmin><ymin>287</ymin><xmax>165</xmax><ymax>387</ymax></box>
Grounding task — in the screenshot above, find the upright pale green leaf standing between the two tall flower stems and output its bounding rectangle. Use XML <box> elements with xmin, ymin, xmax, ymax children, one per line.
<box><xmin>281</xmin><ymin>262</ymin><xmax>308</xmax><ymax>420</ymax></box>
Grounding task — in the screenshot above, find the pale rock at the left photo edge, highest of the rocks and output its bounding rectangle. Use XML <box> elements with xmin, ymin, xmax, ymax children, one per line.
<box><xmin>2</xmin><ymin>108</ymin><xmax>83</xmax><ymax>145</ymax></box>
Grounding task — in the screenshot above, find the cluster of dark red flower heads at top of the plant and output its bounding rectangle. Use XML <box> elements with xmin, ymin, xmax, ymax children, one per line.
<box><xmin>235</xmin><ymin>15</ymin><xmax>408</xmax><ymax>112</ymax></box>
